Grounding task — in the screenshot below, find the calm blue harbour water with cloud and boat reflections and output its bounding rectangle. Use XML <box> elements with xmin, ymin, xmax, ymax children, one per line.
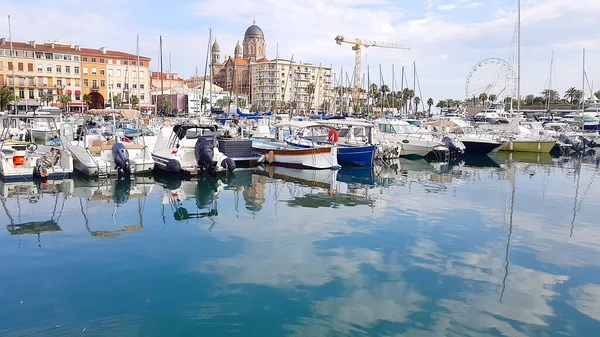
<box><xmin>0</xmin><ymin>155</ymin><xmax>600</xmax><ymax>337</ymax></box>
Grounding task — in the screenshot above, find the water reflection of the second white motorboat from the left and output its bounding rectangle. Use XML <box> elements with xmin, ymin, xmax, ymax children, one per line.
<box><xmin>73</xmin><ymin>177</ymin><xmax>154</xmax><ymax>238</ymax></box>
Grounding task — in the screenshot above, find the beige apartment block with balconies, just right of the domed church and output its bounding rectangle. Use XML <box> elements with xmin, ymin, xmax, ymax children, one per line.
<box><xmin>250</xmin><ymin>59</ymin><xmax>333</xmax><ymax>112</ymax></box>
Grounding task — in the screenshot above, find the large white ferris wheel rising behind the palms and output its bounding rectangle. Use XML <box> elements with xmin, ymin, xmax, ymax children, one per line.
<box><xmin>465</xmin><ymin>58</ymin><xmax>516</xmax><ymax>102</ymax></box>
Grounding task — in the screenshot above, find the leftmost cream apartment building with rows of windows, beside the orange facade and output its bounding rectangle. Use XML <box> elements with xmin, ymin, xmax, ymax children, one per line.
<box><xmin>0</xmin><ymin>38</ymin><xmax>82</xmax><ymax>111</ymax></box>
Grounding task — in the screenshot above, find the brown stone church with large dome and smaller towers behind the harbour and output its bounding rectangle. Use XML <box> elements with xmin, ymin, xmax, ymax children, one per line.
<box><xmin>211</xmin><ymin>22</ymin><xmax>269</xmax><ymax>96</ymax></box>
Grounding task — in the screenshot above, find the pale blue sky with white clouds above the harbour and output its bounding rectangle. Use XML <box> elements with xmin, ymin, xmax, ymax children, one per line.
<box><xmin>0</xmin><ymin>0</ymin><xmax>600</xmax><ymax>100</ymax></box>
